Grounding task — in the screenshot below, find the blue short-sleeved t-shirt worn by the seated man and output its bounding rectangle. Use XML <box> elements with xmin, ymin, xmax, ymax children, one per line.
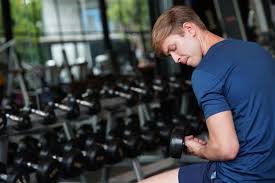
<box><xmin>192</xmin><ymin>40</ymin><xmax>275</xmax><ymax>183</ymax></box>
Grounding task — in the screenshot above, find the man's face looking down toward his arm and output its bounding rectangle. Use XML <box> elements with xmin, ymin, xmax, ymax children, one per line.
<box><xmin>162</xmin><ymin>32</ymin><xmax>202</xmax><ymax>67</ymax></box>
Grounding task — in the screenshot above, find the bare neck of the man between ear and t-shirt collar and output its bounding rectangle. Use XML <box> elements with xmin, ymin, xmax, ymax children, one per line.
<box><xmin>199</xmin><ymin>31</ymin><xmax>224</xmax><ymax>56</ymax></box>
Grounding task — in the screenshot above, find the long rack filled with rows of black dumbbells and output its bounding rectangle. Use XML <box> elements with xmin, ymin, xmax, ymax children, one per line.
<box><xmin>0</xmin><ymin>77</ymin><xmax>205</xmax><ymax>183</ymax></box>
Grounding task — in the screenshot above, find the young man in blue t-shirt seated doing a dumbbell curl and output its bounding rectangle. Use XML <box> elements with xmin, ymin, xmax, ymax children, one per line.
<box><xmin>142</xmin><ymin>6</ymin><xmax>275</xmax><ymax>183</ymax></box>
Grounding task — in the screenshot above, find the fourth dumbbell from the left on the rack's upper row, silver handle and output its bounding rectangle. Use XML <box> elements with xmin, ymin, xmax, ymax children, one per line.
<box><xmin>66</xmin><ymin>94</ymin><xmax>101</xmax><ymax>115</ymax></box>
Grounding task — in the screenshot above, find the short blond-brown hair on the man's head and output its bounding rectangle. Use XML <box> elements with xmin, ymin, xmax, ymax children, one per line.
<box><xmin>152</xmin><ymin>6</ymin><xmax>207</xmax><ymax>55</ymax></box>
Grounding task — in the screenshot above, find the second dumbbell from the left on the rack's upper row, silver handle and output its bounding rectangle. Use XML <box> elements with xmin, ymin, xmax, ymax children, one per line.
<box><xmin>21</xmin><ymin>106</ymin><xmax>57</xmax><ymax>125</ymax></box>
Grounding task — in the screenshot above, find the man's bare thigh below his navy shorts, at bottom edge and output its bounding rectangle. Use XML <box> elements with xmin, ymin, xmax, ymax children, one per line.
<box><xmin>139</xmin><ymin>168</ymin><xmax>179</xmax><ymax>183</ymax></box>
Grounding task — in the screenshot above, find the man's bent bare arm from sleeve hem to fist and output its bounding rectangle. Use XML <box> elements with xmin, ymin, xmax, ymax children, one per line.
<box><xmin>185</xmin><ymin>111</ymin><xmax>239</xmax><ymax>161</ymax></box>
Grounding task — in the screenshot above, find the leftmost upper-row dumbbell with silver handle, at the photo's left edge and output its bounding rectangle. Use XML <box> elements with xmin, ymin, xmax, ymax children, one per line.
<box><xmin>0</xmin><ymin>111</ymin><xmax>32</xmax><ymax>131</ymax></box>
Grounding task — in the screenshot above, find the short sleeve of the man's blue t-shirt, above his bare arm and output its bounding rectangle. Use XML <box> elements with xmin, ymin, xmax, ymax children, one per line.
<box><xmin>192</xmin><ymin>70</ymin><xmax>230</xmax><ymax>119</ymax></box>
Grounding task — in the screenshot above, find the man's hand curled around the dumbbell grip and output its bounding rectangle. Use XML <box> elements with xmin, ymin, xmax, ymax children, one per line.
<box><xmin>184</xmin><ymin>135</ymin><xmax>207</xmax><ymax>158</ymax></box>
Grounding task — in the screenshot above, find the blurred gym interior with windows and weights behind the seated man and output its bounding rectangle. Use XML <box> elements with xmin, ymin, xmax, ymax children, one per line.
<box><xmin>0</xmin><ymin>0</ymin><xmax>275</xmax><ymax>183</ymax></box>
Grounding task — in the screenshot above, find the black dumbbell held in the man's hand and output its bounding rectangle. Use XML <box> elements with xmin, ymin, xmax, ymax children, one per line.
<box><xmin>169</xmin><ymin>126</ymin><xmax>190</xmax><ymax>158</ymax></box>
